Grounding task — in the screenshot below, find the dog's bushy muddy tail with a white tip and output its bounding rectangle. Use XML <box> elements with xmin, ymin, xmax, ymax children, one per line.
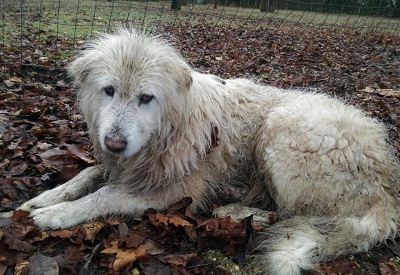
<box><xmin>251</xmin><ymin>199</ymin><xmax>399</xmax><ymax>274</ymax></box>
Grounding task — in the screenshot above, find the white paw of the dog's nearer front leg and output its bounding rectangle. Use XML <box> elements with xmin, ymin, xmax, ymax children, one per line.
<box><xmin>30</xmin><ymin>203</ymin><xmax>84</xmax><ymax>229</ymax></box>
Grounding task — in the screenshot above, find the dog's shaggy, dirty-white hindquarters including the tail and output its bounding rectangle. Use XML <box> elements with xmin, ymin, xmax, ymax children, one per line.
<box><xmin>253</xmin><ymin>101</ymin><xmax>400</xmax><ymax>274</ymax></box>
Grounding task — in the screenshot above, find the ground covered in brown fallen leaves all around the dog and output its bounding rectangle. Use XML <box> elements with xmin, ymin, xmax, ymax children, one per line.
<box><xmin>0</xmin><ymin>22</ymin><xmax>400</xmax><ymax>275</ymax></box>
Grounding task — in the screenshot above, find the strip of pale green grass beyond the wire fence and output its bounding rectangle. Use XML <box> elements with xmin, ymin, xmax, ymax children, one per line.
<box><xmin>0</xmin><ymin>0</ymin><xmax>399</xmax><ymax>42</ymax></box>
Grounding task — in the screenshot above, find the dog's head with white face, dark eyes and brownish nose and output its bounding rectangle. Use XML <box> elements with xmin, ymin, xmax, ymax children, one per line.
<box><xmin>68</xmin><ymin>29</ymin><xmax>192</xmax><ymax>157</ymax></box>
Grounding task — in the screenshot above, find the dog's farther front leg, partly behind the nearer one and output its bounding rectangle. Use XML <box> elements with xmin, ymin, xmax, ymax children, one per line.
<box><xmin>18</xmin><ymin>166</ymin><xmax>105</xmax><ymax>212</ymax></box>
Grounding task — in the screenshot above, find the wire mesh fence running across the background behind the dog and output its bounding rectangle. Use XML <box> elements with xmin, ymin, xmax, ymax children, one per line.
<box><xmin>0</xmin><ymin>0</ymin><xmax>400</xmax><ymax>85</ymax></box>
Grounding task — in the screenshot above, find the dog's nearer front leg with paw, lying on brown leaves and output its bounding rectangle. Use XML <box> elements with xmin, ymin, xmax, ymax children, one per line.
<box><xmin>30</xmin><ymin>185</ymin><xmax>150</xmax><ymax>229</ymax></box>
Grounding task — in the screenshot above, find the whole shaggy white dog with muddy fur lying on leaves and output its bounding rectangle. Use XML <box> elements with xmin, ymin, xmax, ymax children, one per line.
<box><xmin>21</xmin><ymin>29</ymin><xmax>400</xmax><ymax>274</ymax></box>
